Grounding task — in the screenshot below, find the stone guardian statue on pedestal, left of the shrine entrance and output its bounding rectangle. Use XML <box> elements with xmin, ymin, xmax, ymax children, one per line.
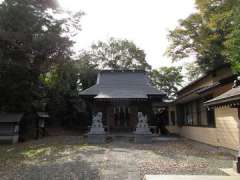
<box><xmin>88</xmin><ymin>112</ymin><xmax>106</xmax><ymax>144</ymax></box>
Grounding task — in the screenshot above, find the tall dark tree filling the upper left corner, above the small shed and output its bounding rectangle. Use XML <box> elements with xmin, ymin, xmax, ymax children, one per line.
<box><xmin>0</xmin><ymin>0</ymin><xmax>81</xmax><ymax>111</ymax></box>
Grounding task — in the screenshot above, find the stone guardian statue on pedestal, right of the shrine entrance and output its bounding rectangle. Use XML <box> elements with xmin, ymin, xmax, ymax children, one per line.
<box><xmin>134</xmin><ymin>112</ymin><xmax>152</xmax><ymax>143</ymax></box>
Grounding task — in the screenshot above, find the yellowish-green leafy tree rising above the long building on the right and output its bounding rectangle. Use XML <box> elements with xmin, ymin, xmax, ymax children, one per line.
<box><xmin>167</xmin><ymin>0</ymin><xmax>238</xmax><ymax>72</ymax></box>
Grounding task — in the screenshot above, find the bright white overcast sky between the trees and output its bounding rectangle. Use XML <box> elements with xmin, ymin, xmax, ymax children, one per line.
<box><xmin>58</xmin><ymin>0</ymin><xmax>196</xmax><ymax>68</ymax></box>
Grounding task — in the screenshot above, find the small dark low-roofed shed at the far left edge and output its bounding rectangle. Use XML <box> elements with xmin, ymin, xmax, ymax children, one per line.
<box><xmin>0</xmin><ymin>113</ymin><xmax>23</xmax><ymax>144</ymax></box>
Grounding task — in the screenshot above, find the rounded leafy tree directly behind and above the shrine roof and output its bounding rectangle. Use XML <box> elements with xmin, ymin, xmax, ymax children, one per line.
<box><xmin>81</xmin><ymin>38</ymin><xmax>151</xmax><ymax>71</ymax></box>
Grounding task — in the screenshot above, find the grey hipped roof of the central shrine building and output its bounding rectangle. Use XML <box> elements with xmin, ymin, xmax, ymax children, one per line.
<box><xmin>80</xmin><ymin>70</ymin><xmax>165</xmax><ymax>99</ymax></box>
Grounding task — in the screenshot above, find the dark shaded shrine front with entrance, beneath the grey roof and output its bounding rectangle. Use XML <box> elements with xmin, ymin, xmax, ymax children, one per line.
<box><xmin>92</xmin><ymin>99</ymin><xmax>164</xmax><ymax>133</ymax></box>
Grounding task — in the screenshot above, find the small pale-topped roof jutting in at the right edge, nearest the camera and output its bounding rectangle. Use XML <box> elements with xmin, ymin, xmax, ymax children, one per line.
<box><xmin>205</xmin><ymin>86</ymin><xmax>240</xmax><ymax>106</ymax></box>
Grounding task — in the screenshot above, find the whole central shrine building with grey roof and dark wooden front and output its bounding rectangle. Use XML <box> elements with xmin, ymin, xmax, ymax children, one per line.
<box><xmin>80</xmin><ymin>70</ymin><xmax>168</xmax><ymax>132</ymax></box>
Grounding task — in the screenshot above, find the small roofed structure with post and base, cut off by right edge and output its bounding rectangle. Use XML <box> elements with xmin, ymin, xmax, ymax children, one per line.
<box><xmin>205</xmin><ymin>78</ymin><xmax>240</xmax><ymax>173</ymax></box>
